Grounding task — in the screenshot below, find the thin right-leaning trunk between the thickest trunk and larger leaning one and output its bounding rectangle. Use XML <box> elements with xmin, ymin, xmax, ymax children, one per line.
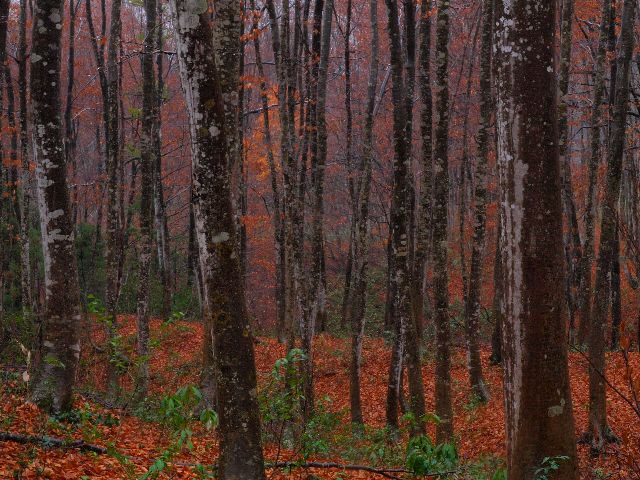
<box><xmin>577</xmin><ymin>0</ymin><xmax>611</xmax><ymax>345</ymax></box>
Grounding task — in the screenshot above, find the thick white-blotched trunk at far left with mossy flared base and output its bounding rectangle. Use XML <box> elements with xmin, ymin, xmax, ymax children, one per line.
<box><xmin>31</xmin><ymin>0</ymin><xmax>81</xmax><ymax>412</ymax></box>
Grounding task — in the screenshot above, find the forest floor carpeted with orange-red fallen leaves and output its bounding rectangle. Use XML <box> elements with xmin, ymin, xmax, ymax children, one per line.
<box><xmin>0</xmin><ymin>316</ymin><xmax>640</xmax><ymax>480</ymax></box>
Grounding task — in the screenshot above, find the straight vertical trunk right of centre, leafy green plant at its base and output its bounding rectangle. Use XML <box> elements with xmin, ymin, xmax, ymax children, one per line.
<box><xmin>433</xmin><ymin>0</ymin><xmax>453</xmax><ymax>443</ymax></box>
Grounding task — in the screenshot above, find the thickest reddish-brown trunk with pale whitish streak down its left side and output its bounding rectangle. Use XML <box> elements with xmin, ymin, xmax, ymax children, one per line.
<box><xmin>496</xmin><ymin>0</ymin><xmax>578</xmax><ymax>480</ymax></box>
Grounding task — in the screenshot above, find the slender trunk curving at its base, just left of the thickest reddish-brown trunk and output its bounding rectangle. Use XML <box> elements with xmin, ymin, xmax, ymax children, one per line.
<box><xmin>463</xmin><ymin>0</ymin><xmax>495</xmax><ymax>402</ymax></box>
